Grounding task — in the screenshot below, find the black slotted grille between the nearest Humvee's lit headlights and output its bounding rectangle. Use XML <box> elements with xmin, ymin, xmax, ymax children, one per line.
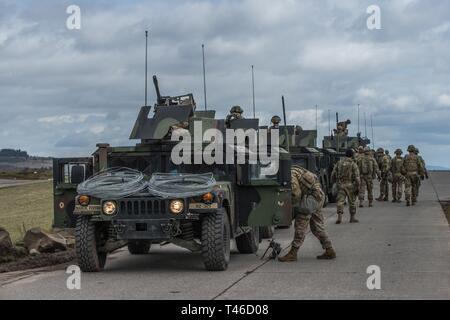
<box><xmin>119</xmin><ymin>199</ymin><xmax>167</xmax><ymax>216</ymax></box>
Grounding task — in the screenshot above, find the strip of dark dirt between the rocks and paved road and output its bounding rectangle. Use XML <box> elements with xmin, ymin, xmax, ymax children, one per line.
<box><xmin>0</xmin><ymin>249</ymin><xmax>75</xmax><ymax>273</ymax></box>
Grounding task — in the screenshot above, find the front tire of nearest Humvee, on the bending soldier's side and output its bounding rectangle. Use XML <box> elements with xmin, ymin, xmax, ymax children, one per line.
<box><xmin>201</xmin><ymin>208</ymin><xmax>231</xmax><ymax>271</ymax></box>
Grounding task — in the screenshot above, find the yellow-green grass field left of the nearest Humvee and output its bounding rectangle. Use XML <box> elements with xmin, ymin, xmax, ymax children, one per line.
<box><xmin>0</xmin><ymin>181</ymin><xmax>53</xmax><ymax>242</ymax></box>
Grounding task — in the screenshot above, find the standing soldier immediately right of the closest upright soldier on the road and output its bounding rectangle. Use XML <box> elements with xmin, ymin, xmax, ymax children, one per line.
<box><xmin>357</xmin><ymin>147</ymin><xmax>380</xmax><ymax>208</ymax></box>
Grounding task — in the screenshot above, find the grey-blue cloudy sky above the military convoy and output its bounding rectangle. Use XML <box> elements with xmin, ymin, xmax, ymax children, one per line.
<box><xmin>0</xmin><ymin>0</ymin><xmax>450</xmax><ymax>167</ymax></box>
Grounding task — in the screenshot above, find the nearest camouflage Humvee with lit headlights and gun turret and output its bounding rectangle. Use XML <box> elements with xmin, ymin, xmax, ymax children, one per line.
<box><xmin>54</xmin><ymin>77</ymin><xmax>292</xmax><ymax>272</ymax></box>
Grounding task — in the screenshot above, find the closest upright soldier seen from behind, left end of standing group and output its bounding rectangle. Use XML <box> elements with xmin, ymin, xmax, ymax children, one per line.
<box><xmin>331</xmin><ymin>149</ymin><xmax>360</xmax><ymax>224</ymax></box>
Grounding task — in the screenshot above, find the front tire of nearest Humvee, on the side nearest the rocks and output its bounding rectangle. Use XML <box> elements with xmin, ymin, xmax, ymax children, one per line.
<box><xmin>75</xmin><ymin>216</ymin><xmax>107</xmax><ymax>272</ymax></box>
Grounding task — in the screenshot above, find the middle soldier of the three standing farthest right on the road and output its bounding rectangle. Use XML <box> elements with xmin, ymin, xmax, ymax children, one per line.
<box><xmin>403</xmin><ymin>145</ymin><xmax>425</xmax><ymax>207</ymax></box>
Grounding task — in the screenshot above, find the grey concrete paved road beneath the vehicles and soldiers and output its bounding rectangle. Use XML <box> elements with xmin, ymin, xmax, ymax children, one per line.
<box><xmin>0</xmin><ymin>173</ymin><xmax>450</xmax><ymax>299</ymax></box>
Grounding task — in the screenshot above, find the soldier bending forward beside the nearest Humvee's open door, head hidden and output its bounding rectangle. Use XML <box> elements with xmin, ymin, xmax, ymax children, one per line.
<box><xmin>278</xmin><ymin>166</ymin><xmax>336</xmax><ymax>262</ymax></box>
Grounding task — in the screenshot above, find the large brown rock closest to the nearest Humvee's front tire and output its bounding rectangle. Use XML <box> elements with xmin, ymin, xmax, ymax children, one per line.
<box><xmin>23</xmin><ymin>228</ymin><xmax>67</xmax><ymax>253</ymax></box>
